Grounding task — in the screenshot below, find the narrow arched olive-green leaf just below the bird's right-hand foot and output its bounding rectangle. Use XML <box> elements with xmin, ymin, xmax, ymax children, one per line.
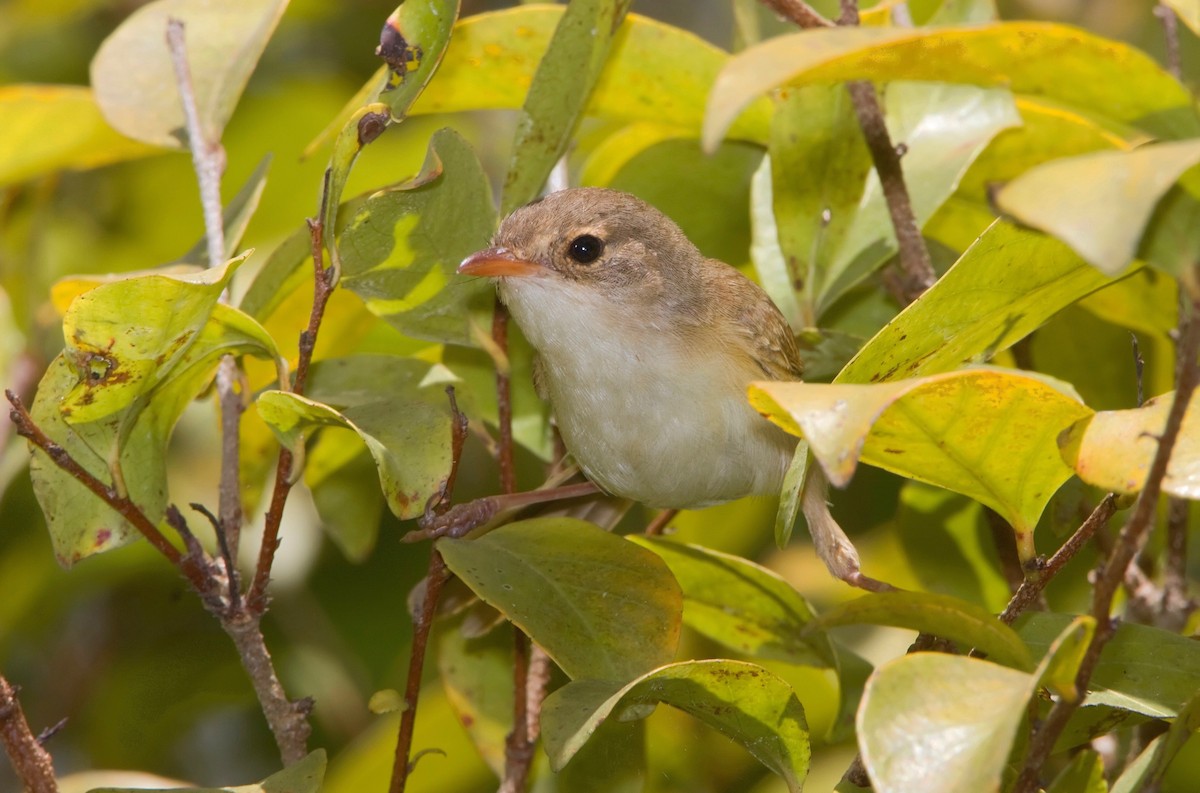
<box><xmin>810</xmin><ymin>591</ymin><xmax>1033</xmax><ymax>672</ymax></box>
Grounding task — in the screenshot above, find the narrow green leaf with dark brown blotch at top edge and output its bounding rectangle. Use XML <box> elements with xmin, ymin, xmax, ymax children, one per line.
<box><xmin>378</xmin><ymin>0</ymin><xmax>462</xmax><ymax>121</ymax></box>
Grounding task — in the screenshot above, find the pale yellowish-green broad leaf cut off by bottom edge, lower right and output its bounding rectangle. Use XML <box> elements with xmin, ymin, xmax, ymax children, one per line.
<box><xmin>858</xmin><ymin>653</ymin><xmax>1037</xmax><ymax>793</ymax></box>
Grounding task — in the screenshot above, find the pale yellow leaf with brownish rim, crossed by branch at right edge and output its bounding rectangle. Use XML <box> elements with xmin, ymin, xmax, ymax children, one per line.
<box><xmin>1061</xmin><ymin>392</ymin><xmax>1200</xmax><ymax>500</ymax></box>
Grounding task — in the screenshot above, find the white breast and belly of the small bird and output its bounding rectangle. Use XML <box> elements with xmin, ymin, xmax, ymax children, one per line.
<box><xmin>500</xmin><ymin>277</ymin><xmax>796</xmax><ymax>507</ymax></box>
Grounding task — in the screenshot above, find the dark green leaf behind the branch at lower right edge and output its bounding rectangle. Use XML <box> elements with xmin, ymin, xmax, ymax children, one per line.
<box><xmin>1016</xmin><ymin>613</ymin><xmax>1200</xmax><ymax>719</ymax></box>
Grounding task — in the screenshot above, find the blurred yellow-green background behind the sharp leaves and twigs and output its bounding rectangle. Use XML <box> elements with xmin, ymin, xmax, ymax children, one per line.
<box><xmin>0</xmin><ymin>0</ymin><xmax>1198</xmax><ymax>791</ymax></box>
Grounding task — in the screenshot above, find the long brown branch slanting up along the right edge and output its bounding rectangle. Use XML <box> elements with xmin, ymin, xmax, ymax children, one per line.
<box><xmin>1014</xmin><ymin>301</ymin><xmax>1200</xmax><ymax>793</ymax></box>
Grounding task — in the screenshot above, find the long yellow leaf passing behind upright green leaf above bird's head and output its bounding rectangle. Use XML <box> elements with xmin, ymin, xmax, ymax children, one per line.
<box><xmin>408</xmin><ymin>5</ymin><xmax>770</xmax><ymax>142</ymax></box>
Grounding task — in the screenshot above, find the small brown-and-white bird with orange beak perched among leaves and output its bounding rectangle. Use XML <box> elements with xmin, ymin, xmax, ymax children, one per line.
<box><xmin>458</xmin><ymin>187</ymin><xmax>886</xmax><ymax>589</ymax></box>
